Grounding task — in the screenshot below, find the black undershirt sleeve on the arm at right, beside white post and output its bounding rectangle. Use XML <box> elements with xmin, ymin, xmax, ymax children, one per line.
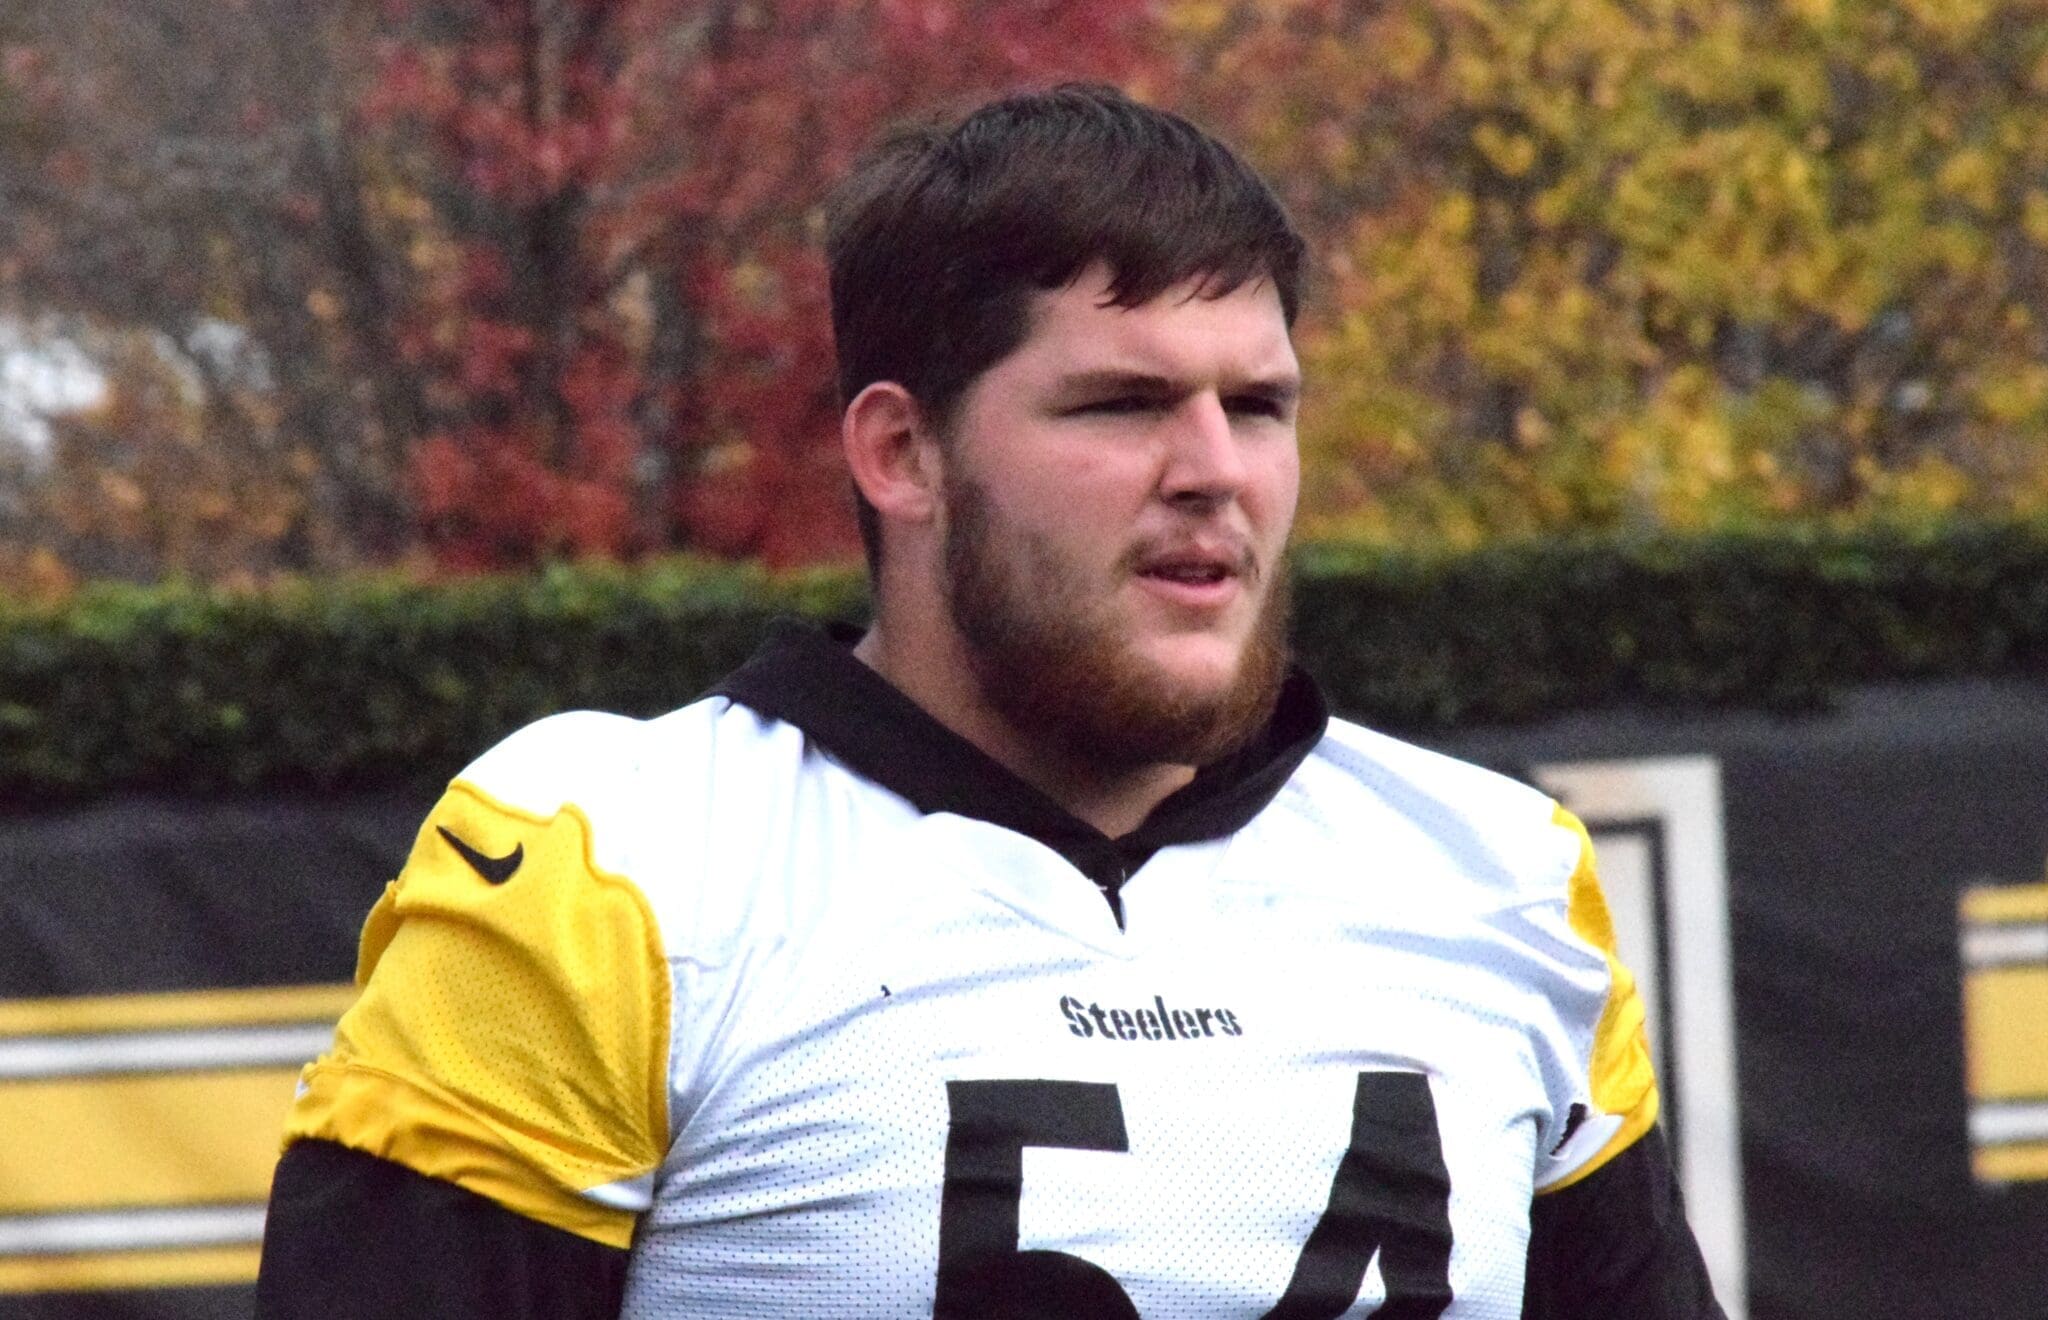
<box><xmin>1522</xmin><ymin>1128</ymin><xmax>1726</xmax><ymax>1320</ymax></box>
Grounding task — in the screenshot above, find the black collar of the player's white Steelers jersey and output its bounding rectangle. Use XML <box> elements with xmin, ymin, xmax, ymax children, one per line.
<box><xmin>711</xmin><ymin>620</ymin><xmax>1329</xmax><ymax>884</ymax></box>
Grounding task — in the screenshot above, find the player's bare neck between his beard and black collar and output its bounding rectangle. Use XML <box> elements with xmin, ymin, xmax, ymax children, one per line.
<box><xmin>854</xmin><ymin>622</ymin><xmax>1194</xmax><ymax>839</ymax></box>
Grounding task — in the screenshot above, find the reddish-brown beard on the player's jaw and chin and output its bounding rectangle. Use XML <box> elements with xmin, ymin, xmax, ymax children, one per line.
<box><xmin>944</xmin><ymin>470</ymin><xmax>1288</xmax><ymax>772</ymax></box>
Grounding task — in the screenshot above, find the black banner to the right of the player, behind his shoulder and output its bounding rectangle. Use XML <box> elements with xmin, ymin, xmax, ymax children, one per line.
<box><xmin>1436</xmin><ymin>684</ymin><xmax>2048</xmax><ymax>1320</ymax></box>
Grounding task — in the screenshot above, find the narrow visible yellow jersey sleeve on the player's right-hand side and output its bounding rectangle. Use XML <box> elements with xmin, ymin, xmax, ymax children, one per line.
<box><xmin>1536</xmin><ymin>806</ymin><xmax>1659</xmax><ymax>1193</ymax></box>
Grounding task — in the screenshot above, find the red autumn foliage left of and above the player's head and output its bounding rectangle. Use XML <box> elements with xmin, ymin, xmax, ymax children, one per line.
<box><xmin>374</xmin><ymin>0</ymin><xmax>1163</xmax><ymax>565</ymax></box>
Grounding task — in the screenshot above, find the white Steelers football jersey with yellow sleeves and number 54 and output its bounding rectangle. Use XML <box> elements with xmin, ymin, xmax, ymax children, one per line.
<box><xmin>291</xmin><ymin>634</ymin><xmax>1657</xmax><ymax>1320</ymax></box>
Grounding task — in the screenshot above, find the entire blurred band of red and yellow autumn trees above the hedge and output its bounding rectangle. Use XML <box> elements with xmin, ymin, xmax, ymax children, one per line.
<box><xmin>0</xmin><ymin>0</ymin><xmax>2048</xmax><ymax>589</ymax></box>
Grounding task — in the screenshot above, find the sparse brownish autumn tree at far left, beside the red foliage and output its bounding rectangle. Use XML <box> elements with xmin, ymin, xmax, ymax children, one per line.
<box><xmin>0</xmin><ymin>0</ymin><xmax>420</xmax><ymax>575</ymax></box>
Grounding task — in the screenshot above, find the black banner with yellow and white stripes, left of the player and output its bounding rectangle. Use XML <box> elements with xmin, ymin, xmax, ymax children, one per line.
<box><xmin>0</xmin><ymin>796</ymin><xmax>430</xmax><ymax>1320</ymax></box>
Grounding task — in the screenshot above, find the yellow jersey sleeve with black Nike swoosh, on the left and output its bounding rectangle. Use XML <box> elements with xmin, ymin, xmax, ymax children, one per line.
<box><xmin>285</xmin><ymin>780</ymin><xmax>670</xmax><ymax>1246</ymax></box>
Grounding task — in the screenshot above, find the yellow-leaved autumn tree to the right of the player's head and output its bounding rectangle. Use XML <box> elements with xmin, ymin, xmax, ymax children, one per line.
<box><xmin>1176</xmin><ymin>0</ymin><xmax>2048</xmax><ymax>540</ymax></box>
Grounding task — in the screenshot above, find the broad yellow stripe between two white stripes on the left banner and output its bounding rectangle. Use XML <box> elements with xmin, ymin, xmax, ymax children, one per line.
<box><xmin>0</xmin><ymin>1068</ymin><xmax>299</xmax><ymax>1214</ymax></box>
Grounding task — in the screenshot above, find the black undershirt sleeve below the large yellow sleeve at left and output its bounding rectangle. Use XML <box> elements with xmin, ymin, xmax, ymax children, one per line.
<box><xmin>256</xmin><ymin>1140</ymin><xmax>627</xmax><ymax>1320</ymax></box>
